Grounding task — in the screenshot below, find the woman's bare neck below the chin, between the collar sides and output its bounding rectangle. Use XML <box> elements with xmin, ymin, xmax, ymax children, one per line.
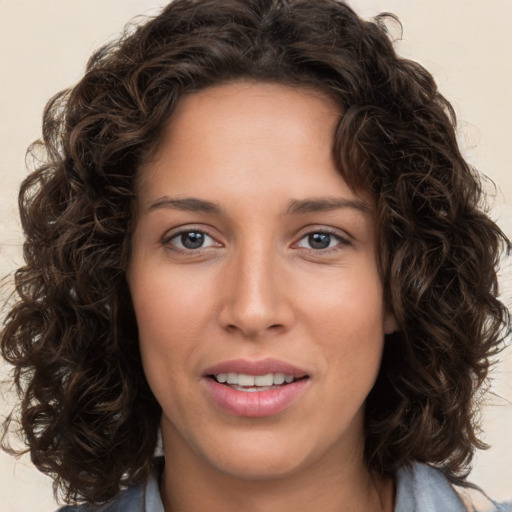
<box><xmin>161</xmin><ymin>436</ymin><xmax>394</xmax><ymax>512</ymax></box>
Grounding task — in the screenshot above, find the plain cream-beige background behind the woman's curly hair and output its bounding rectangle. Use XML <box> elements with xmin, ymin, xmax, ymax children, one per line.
<box><xmin>0</xmin><ymin>0</ymin><xmax>512</xmax><ymax>512</ymax></box>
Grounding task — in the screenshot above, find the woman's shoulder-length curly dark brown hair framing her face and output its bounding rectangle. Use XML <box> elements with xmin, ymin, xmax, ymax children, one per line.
<box><xmin>1</xmin><ymin>0</ymin><xmax>510</xmax><ymax>503</ymax></box>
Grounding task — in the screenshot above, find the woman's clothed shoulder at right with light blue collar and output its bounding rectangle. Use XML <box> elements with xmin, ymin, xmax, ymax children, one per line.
<box><xmin>395</xmin><ymin>462</ymin><xmax>512</xmax><ymax>512</ymax></box>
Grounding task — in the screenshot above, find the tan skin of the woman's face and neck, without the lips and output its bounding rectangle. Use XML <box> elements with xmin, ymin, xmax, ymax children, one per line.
<box><xmin>128</xmin><ymin>82</ymin><xmax>395</xmax><ymax>512</ymax></box>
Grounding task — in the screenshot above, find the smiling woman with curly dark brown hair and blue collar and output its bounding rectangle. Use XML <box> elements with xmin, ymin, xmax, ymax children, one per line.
<box><xmin>2</xmin><ymin>0</ymin><xmax>510</xmax><ymax>512</ymax></box>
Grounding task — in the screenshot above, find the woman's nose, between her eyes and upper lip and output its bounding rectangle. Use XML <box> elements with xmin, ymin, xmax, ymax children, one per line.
<box><xmin>219</xmin><ymin>247</ymin><xmax>294</xmax><ymax>339</ymax></box>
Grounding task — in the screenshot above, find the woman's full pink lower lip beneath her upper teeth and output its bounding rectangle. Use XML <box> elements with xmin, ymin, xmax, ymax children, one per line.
<box><xmin>205</xmin><ymin>377</ymin><xmax>309</xmax><ymax>418</ymax></box>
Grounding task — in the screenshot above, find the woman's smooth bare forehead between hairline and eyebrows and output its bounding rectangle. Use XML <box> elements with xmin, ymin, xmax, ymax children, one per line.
<box><xmin>138</xmin><ymin>81</ymin><xmax>374</xmax><ymax>210</ymax></box>
